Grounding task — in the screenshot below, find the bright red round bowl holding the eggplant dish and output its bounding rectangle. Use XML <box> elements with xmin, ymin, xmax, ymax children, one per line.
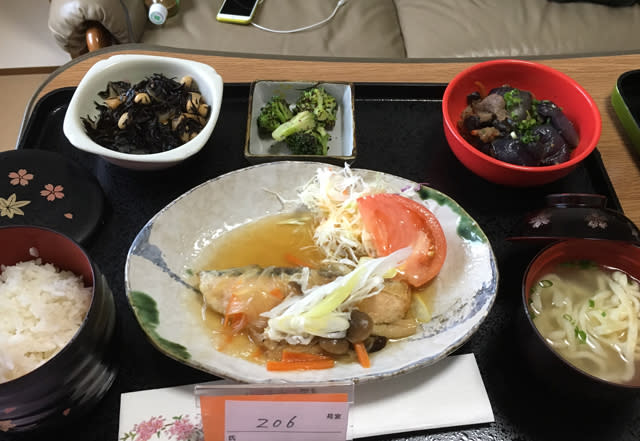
<box><xmin>442</xmin><ymin>60</ymin><xmax>601</xmax><ymax>186</ymax></box>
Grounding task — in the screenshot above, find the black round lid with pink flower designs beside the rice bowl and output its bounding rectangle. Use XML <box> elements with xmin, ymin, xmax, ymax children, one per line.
<box><xmin>0</xmin><ymin>149</ymin><xmax>104</xmax><ymax>243</ymax></box>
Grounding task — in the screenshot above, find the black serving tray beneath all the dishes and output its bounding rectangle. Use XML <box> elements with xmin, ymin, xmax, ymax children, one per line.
<box><xmin>10</xmin><ymin>83</ymin><xmax>640</xmax><ymax>441</ymax></box>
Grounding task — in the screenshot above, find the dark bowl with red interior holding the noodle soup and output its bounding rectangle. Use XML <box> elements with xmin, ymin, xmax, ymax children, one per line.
<box><xmin>519</xmin><ymin>239</ymin><xmax>640</xmax><ymax>400</ymax></box>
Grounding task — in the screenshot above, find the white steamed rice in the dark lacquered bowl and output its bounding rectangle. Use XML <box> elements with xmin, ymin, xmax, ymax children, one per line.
<box><xmin>0</xmin><ymin>259</ymin><xmax>91</xmax><ymax>383</ymax></box>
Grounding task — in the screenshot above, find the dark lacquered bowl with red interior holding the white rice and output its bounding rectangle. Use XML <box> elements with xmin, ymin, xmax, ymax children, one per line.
<box><xmin>0</xmin><ymin>226</ymin><xmax>117</xmax><ymax>432</ymax></box>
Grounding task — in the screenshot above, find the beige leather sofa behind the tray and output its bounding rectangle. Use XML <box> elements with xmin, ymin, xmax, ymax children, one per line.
<box><xmin>49</xmin><ymin>0</ymin><xmax>640</xmax><ymax>59</ymax></box>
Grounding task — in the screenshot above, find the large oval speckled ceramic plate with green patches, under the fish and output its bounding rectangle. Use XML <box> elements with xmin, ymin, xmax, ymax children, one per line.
<box><xmin>125</xmin><ymin>161</ymin><xmax>498</xmax><ymax>383</ymax></box>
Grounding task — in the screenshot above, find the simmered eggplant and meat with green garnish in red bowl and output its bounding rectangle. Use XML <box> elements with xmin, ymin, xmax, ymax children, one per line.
<box><xmin>458</xmin><ymin>84</ymin><xmax>579</xmax><ymax>166</ymax></box>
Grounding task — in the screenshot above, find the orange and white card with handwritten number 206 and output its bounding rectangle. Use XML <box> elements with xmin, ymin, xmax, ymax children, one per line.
<box><xmin>195</xmin><ymin>382</ymin><xmax>354</xmax><ymax>441</ymax></box>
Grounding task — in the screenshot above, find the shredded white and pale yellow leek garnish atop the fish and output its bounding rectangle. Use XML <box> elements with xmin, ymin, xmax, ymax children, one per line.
<box><xmin>262</xmin><ymin>247</ymin><xmax>411</xmax><ymax>344</ymax></box>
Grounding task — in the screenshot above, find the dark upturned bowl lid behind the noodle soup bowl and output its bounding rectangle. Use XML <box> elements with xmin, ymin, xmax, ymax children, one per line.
<box><xmin>508</xmin><ymin>193</ymin><xmax>640</xmax><ymax>245</ymax></box>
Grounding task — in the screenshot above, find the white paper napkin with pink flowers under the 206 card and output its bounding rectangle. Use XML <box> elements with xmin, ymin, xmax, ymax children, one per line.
<box><xmin>118</xmin><ymin>354</ymin><xmax>494</xmax><ymax>441</ymax></box>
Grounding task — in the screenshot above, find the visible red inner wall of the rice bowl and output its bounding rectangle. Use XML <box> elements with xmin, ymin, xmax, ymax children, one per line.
<box><xmin>0</xmin><ymin>226</ymin><xmax>93</xmax><ymax>285</ymax></box>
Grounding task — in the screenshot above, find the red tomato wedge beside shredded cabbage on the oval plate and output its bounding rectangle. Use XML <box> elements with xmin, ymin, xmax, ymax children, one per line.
<box><xmin>358</xmin><ymin>193</ymin><xmax>447</xmax><ymax>287</ymax></box>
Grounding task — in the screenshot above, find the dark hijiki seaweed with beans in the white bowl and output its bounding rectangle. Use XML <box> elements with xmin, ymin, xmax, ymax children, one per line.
<box><xmin>82</xmin><ymin>73</ymin><xmax>210</xmax><ymax>154</ymax></box>
